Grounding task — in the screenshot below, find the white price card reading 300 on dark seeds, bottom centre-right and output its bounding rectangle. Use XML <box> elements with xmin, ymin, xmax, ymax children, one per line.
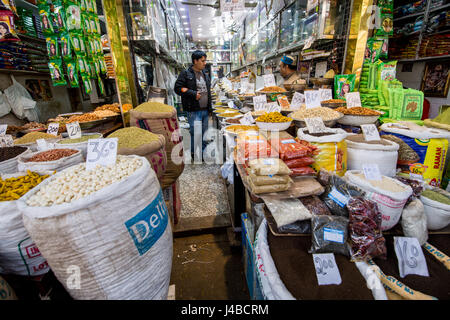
<box><xmin>313</xmin><ymin>253</ymin><xmax>342</xmax><ymax>286</ymax></box>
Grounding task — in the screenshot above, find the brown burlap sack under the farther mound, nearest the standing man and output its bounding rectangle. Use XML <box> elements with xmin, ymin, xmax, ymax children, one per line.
<box><xmin>130</xmin><ymin>108</ymin><xmax>184</xmax><ymax>189</ymax></box>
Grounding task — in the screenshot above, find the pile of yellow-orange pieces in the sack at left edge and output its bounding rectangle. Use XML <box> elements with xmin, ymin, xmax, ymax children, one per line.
<box><xmin>0</xmin><ymin>170</ymin><xmax>49</xmax><ymax>201</ymax></box>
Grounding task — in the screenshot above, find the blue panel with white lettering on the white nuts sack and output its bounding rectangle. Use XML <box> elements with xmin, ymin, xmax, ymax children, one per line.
<box><xmin>125</xmin><ymin>191</ymin><xmax>169</xmax><ymax>256</ymax></box>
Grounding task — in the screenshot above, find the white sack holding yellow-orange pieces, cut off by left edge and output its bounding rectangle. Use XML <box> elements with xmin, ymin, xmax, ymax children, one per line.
<box><xmin>0</xmin><ymin>170</ymin><xmax>50</xmax><ymax>276</ymax></box>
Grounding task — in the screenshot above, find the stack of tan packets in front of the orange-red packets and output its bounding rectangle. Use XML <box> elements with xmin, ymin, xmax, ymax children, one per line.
<box><xmin>247</xmin><ymin>158</ymin><xmax>293</xmax><ymax>194</ymax></box>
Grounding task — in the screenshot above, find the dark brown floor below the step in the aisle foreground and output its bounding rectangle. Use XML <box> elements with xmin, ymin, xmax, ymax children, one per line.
<box><xmin>170</xmin><ymin>229</ymin><xmax>250</xmax><ymax>300</ymax></box>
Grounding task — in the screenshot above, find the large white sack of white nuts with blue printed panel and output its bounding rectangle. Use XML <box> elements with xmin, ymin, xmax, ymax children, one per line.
<box><xmin>18</xmin><ymin>155</ymin><xmax>172</xmax><ymax>300</ymax></box>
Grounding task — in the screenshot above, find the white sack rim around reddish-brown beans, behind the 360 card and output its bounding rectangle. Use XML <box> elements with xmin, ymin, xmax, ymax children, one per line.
<box><xmin>17</xmin><ymin>147</ymin><xmax>84</xmax><ymax>171</ymax></box>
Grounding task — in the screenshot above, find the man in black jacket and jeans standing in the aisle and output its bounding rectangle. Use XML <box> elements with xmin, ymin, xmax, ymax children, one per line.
<box><xmin>174</xmin><ymin>50</ymin><xmax>211</xmax><ymax>158</ymax></box>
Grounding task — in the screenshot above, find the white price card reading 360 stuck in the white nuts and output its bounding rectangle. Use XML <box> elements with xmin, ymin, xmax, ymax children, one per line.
<box><xmin>86</xmin><ymin>138</ymin><xmax>118</xmax><ymax>170</ymax></box>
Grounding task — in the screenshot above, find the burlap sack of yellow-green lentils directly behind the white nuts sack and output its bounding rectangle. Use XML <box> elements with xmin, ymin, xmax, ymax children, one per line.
<box><xmin>117</xmin><ymin>134</ymin><xmax>167</xmax><ymax>183</ymax></box>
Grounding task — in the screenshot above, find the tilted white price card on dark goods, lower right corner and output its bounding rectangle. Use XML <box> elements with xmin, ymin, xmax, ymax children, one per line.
<box><xmin>394</xmin><ymin>237</ymin><xmax>430</xmax><ymax>278</ymax></box>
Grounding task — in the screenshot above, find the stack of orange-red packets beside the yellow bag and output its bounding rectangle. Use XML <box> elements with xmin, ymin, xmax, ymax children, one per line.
<box><xmin>268</xmin><ymin>131</ymin><xmax>317</xmax><ymax>177</ymax></box>
